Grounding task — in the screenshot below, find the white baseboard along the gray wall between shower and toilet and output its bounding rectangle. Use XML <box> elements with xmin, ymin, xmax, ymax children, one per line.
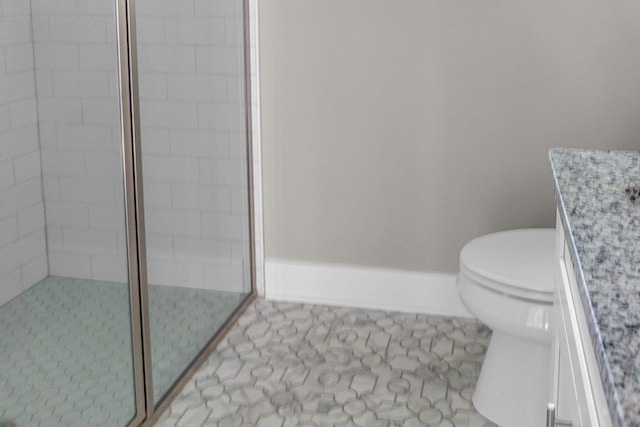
<box><xmin>265</xmin><ymin>258</ymin><xmax>474</xmax><ymax>318</ymax></box>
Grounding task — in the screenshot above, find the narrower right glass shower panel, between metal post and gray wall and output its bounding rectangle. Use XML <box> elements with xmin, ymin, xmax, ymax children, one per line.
<box><xmin>135</xmin><ymin>0</ymin><xmax>252</xmax><ymax>403</ymax></box>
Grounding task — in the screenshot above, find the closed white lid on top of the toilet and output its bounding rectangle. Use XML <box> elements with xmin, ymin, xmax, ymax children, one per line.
<box><xmin>460</xmin><ymin>228</ymin><xmax>555</xmax><ymax>294</ymax></box>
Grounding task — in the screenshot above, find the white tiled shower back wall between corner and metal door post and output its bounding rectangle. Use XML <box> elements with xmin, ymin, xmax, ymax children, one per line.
<box><xmin>32</xmin><ymin>0</ymin><xmax>127</xmax><ymax>288</ymax></box>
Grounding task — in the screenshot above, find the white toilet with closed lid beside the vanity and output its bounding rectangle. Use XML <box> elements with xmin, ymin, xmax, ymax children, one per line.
<box><xmin>457</xmin><ymin>228</ymin><xmax>555</xmax><ymax>427</ymax></box>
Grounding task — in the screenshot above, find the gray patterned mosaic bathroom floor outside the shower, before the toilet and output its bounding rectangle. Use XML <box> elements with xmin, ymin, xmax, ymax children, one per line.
<box><xmin>156</xmin><ymin>299</ymin><xmax>494</xmax><ymax>427</ymax></box>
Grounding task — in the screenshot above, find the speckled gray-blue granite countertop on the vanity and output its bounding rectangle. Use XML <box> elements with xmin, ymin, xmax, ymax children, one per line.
<box><xmin>549</xmin><ymin>149</ymin><xmax>640</xmax><ymax>427</ymax></box>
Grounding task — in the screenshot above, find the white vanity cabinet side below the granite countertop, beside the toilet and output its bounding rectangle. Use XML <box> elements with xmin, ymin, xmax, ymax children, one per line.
<box><xmin>550</xmin><ymin>216</ymin><xmax>612</xmax><ymax>427</ymax></box>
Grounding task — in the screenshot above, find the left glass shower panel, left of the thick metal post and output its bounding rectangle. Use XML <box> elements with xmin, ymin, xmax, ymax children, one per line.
<box><xmin>0</xmin><ymin>0</ymin><xmax>144</xmax><ymax>426</ymax></box>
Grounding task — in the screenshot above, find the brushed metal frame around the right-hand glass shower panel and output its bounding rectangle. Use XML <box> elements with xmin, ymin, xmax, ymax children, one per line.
<box><xmin>116</xmin><ymin>0</ymin><xmax>256</xmax><ymax>427</ymax></box>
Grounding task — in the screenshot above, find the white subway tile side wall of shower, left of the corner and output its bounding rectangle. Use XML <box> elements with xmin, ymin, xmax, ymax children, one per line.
<box><xmin>0</xmin><ymin>0</ymin><xmax>48</xmax><ymax>305</ymax></box>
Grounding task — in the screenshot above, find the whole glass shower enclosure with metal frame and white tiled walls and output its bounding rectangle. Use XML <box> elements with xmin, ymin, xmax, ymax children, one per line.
<box><xmin>0</xmin><ymin>0</ymin><xmax>255</xmax><ymax>426</ymax></box>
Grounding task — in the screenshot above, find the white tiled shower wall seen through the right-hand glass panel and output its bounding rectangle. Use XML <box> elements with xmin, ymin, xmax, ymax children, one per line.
<box><xmin>137</xmin><ymin>0</ymin><xmax>248</xmax><ymax>291</ymax></box>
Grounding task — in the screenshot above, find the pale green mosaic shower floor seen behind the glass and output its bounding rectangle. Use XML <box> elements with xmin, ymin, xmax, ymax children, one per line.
<box><xmin>0</xmin><ymin>277</ymin><xmax>246</xmax><ymax>427</ymax></box>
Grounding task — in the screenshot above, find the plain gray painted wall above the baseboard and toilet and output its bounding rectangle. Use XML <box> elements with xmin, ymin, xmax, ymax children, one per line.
<box><xmin>260</xmin><ymin>0</ymin><xmax>640</xmax><ymax>272</ymax></box>
